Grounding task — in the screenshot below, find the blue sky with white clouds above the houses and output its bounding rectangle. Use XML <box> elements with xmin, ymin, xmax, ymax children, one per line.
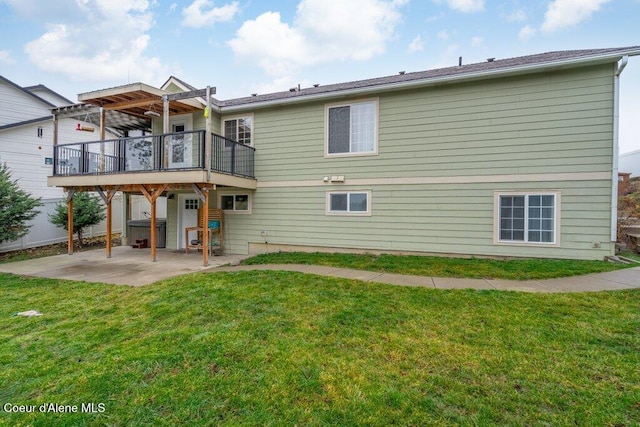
<box><xmin>0</xmin><ymin>0</ymin><xmax>640</xmax><ymax>153</ymax></box>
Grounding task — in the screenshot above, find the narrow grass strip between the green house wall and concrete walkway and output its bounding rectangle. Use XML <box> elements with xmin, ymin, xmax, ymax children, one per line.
<box><xmin>244</xmin><ymin>252</ymin><xmax>632</xmax><ymax>280</ymax></box>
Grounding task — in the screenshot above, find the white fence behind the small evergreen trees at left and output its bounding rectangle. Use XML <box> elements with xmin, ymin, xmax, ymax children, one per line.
<box><xmin>0</xmin><ymin>194</ymin><xmax>122</xmax><ymax>252</ymax></box>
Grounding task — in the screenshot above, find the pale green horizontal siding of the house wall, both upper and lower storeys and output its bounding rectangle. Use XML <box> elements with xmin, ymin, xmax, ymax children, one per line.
<box><xmin>168</xmin><ymin>64</ymin><xmax>615</xmax><ymax>259</ymax></box>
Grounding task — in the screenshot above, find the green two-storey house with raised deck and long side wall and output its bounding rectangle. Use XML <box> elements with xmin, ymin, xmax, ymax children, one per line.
<box><xmin>49</xmin><ymin>47</ymin><xmax>640</xmax><ymax>263</ymax></box>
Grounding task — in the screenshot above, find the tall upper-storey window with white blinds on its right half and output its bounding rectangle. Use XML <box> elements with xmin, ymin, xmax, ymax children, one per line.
<box><xmin>327</xmin><ymin>101</ymin><xmax>378</xmax><ymax>156</ymax></box>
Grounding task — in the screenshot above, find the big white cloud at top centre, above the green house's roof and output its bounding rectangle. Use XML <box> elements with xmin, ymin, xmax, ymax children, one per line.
<box><xmin>228</xmin><ymin>0</ymin><xmax>406</xmax><ymax>76</ymax></box>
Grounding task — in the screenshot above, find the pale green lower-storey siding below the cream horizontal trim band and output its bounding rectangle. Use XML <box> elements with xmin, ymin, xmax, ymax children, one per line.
<box><xmin>225</xmin><ymin>181</ymin><xmax>611</xmax><ymax>259</ymax></box>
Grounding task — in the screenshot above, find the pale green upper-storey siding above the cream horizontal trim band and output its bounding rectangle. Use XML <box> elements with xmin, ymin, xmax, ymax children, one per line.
<box><xmin>254</xmin><ymin>65</ymin><xmax>614</xmax><ymax>181</ymax></box>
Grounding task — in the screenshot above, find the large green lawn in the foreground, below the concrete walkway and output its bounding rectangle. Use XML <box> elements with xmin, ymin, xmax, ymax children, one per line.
<box><xmin>0</xmin><ymin>271</ymin><xmax>640</xmax><ymax>426</ymax></box>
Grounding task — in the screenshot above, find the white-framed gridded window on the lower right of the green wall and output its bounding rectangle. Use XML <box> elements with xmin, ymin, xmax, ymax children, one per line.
<box><xmin>498</xmin><ymin>194</ymin><xmax>558</xmax><ymax>244</ymax></box>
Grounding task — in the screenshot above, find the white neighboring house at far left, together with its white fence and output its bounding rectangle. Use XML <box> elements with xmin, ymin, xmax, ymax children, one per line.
<box><xmin>0</xmin><ymin>76</ymin><xmax>124</xmax><ymax>251</ymax></box>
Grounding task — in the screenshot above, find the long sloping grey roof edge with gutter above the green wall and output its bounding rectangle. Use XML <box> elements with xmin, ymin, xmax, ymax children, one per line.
<box><xmin>218</xmin><ymin>46</ymin><xmax>640</xmax><ymax>110</ymax></box>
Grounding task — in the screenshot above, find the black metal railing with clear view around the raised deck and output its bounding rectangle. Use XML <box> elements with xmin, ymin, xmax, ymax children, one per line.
<box><xmin>53</xmin><ymin>130</ymin><xmax>255</xmax><ymax>178</ymax></box>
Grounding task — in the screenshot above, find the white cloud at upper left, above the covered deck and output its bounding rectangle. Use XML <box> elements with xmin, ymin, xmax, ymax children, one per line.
<box><xmin>25</xmin><ymin>0</ymin><xmax>167</xmax><ymax>83</ymax></box>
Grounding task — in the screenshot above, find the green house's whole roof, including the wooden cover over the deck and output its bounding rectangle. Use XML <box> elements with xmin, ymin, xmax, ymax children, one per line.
<box><xmin>57</xmin><ymin>46</ymin><xmax>640</xmax><ymax>130</ymax></box>
